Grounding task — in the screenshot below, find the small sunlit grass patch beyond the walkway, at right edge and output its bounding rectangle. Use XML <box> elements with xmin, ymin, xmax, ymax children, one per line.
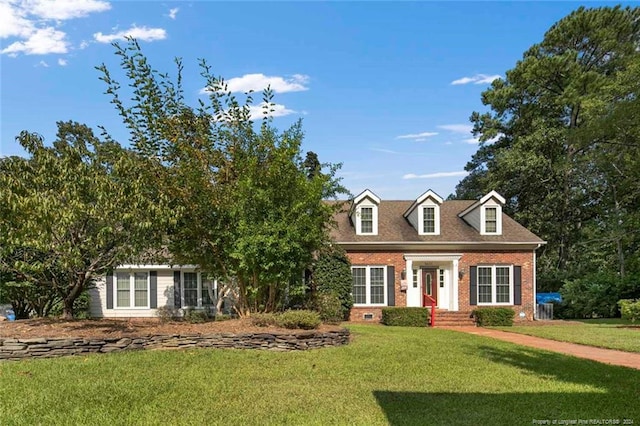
<box><xmin>496</xmin><ymin>318</ymin><xmax>640</xmax><ymax>352</ymax></box>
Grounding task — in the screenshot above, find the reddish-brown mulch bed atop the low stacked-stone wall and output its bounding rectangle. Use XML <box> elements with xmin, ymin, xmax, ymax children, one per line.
<box><xmin>0</xmin><ymin>318</ymin><xmax>341</xmax><ymax>339</ymax></box>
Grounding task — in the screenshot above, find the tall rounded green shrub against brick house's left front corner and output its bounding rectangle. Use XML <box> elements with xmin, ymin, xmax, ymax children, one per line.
<box><xmin>313</xmin><ymin>246</ymin><xmax>353</xmax><ymax>320</ymax></box>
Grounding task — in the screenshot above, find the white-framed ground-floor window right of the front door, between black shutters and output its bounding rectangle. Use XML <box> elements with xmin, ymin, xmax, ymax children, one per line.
<box><xmin>478</xmin><ymin>265</ymin><xmax>513</xmax><ymax>305</ymax></box>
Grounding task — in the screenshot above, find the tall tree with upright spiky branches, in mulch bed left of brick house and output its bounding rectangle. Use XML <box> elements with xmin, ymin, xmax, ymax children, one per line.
<box><xmin>98</xmin><ymin>40</ymin><xmax>344</xmax><ymax>315</ymax></box>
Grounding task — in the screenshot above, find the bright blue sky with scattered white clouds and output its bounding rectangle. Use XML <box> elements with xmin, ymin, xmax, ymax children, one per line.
<box><xmin>0</xmin><ymin>0</ymin><xmax>628</xmax><ymax>199</ymax></box>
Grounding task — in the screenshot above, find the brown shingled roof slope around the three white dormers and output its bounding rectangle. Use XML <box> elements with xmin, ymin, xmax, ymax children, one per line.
<box><xmin>331</xmin><ymin>200</ymin><xmax>544</xmax><ymax>244</ymax></box>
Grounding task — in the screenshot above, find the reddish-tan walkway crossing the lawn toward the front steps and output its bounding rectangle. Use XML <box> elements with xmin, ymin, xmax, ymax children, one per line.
<box><xmin>437</xmin><ymin>327</ymin><xmax>640</xmax><ymax>370</ymax></box>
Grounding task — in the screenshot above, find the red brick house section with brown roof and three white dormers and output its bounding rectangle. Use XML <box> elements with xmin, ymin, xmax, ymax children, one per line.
<box><xmin>332</xmin><ymin>190</ymin><xmax>545</xmax><ymax>321</ymax></box>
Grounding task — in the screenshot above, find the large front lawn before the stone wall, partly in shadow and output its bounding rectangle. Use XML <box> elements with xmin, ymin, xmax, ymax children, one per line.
<box><xmin>0</xmin><ymin>325</ymin><xmax>640</xmax><ymax>425</ymax></box>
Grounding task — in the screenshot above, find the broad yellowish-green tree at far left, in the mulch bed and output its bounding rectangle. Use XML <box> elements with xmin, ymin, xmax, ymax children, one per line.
<box><xmin>0</xmin><ymin>122</ymin><xmax>171</xmax><ymax>318</ymax></box>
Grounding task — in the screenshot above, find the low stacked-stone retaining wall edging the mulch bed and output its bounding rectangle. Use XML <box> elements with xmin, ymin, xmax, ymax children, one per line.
<box><xmin>0</xmin><ymin>330</ymin><xmax>349</xmax><ymax>360</ymax></box>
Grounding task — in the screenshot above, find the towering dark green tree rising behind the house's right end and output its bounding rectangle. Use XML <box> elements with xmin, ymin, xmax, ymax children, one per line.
<box><xmin>456</xmin><ymin>7</ymin><xmax>640</xmax><ymax>286</ymax></box>
